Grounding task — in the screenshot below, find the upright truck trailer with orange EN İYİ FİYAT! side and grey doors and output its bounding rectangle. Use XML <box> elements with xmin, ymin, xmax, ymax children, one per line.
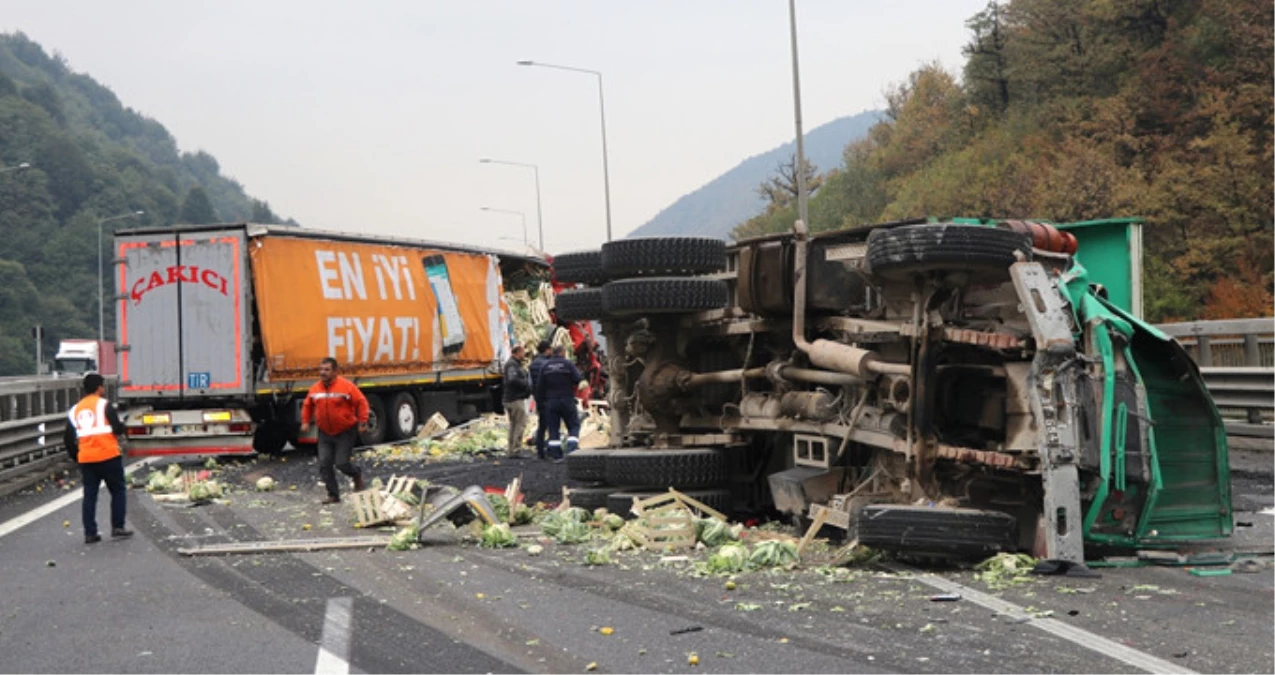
<box><xmin>115</xmin><ymin>225</ymin><xmax>547</xmax><ymax>456</ymax></box>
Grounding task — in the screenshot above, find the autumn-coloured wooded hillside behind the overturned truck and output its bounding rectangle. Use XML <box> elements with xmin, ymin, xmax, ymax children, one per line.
<box><xmin>736</xmin><ymin>0</ymin><xmax>1275</xmax><ymax>322</ymax></box>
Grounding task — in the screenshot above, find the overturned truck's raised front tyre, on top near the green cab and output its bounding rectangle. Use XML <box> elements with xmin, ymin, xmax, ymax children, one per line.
<box><xmin>867</xmin><ymin>223</ymin><xmax>1031</xmax><ymax>279</ymax></box>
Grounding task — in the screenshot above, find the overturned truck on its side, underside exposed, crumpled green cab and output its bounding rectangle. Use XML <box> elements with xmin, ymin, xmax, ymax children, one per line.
<box><xmin>557</xmin><ymin>221</ymin><xmax>1233</xmax><ymax>563</ymax></box>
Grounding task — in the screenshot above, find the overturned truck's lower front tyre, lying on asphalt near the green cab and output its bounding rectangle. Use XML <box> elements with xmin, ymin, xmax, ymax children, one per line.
<box><xmin>856</xmin><ymin>504</ymin><xmax>1019</xmax><ymax>558</ymax></box>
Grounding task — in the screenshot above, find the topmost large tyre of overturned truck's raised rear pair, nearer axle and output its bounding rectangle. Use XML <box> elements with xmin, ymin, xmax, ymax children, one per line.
<box><xmin>602</xmin><ymin>237</ymin><xmax>725</xmax><ymax>279</ymax></box>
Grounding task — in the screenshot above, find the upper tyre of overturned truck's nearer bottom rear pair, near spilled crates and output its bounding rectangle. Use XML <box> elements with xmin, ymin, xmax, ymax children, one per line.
<box><xmin>606</xmin><ymin>448</ymin><xmax>727</xmax><ymax>489</ymax></box>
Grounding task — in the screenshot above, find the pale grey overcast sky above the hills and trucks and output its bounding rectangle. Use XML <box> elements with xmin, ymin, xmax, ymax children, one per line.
<box><xmin>0</xmin><ymin>0</ymin><xmax>986</xmax><ymax>253</ymax></box>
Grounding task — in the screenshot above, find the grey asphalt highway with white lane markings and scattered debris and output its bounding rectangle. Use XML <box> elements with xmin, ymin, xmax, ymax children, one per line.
<box><xmin>0</xmin><ymin>456</ymin><xmax>1275</xmax><ymax>674</ymax></box>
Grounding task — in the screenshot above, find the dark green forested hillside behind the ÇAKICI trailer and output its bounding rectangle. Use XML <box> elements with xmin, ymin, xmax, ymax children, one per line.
<box><xmin>0</xmin><ymin>33</ymin><xmax>290</xmax><ymax>375</ymax></box>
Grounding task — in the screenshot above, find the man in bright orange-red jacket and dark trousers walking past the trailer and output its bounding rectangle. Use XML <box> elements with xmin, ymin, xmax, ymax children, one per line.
<box><xmin>301</xmin><ymin>356</ymin><xmax>367</xmax><ymax>504</ymax></box>
